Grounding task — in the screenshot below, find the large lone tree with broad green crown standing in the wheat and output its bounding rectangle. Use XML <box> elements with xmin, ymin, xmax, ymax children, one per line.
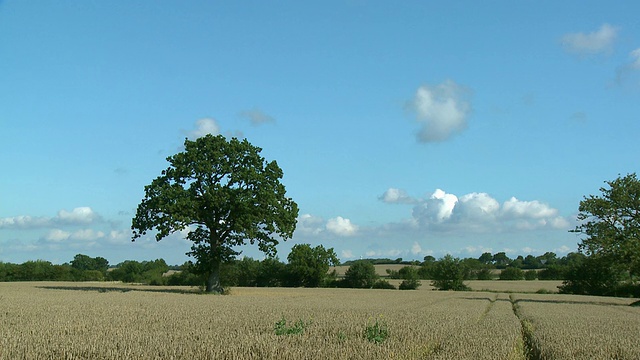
<box><xmin>131</xmin><ymin>135</ymin><xmax>298</xmax><ymax>292</ymax></box>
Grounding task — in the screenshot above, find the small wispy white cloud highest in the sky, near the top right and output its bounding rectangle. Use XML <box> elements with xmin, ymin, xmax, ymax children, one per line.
<box><xmin>561</xmin><ymin>24</ymin><xmax>618</xmax><ymax>55</ymax></box>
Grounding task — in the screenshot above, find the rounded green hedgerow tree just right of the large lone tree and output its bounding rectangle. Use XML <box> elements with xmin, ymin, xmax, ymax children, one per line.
<box><xmin>286</xmin><ymin>244</ymin><xmax>340</xmax><ymax>287</ymax></box>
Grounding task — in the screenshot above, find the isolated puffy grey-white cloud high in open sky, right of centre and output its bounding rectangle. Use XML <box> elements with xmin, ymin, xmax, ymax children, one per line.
<box><xmin>409</xmin><ymin>80</ymin><xmax>471</xmax><ymax>142</ymax></box>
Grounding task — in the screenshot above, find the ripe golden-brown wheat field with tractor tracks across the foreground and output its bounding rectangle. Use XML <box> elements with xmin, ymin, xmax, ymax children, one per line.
<box><xmin>0</xmin><ymin>282</ymin><xmax>640</xmax><ymax>359</ymax></box>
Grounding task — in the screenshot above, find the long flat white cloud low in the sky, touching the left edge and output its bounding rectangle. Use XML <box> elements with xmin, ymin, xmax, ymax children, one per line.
<box><xmin>0</xmin><ymin>206</ymin><xmax>101</xmax><ymax>229</ymax></box>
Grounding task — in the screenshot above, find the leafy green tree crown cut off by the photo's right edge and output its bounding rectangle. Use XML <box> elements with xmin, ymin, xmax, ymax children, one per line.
<box><xmin>573</xmin><ymin>173</ymin><xmax>640</xmax><ymax>275</ymax></box>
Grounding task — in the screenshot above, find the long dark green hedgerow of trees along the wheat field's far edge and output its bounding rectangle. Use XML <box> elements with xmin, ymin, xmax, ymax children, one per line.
<box><xmin>0</xmin><ymin>249</ymin><xmax>640</xmax><ymax>296</ymax></box>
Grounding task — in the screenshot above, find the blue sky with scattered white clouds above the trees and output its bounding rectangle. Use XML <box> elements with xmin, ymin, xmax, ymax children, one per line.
<box><xmin>0</xmin><ymin>0</ymin><xmax>640</xmax><ymax>264</ymax></box>
